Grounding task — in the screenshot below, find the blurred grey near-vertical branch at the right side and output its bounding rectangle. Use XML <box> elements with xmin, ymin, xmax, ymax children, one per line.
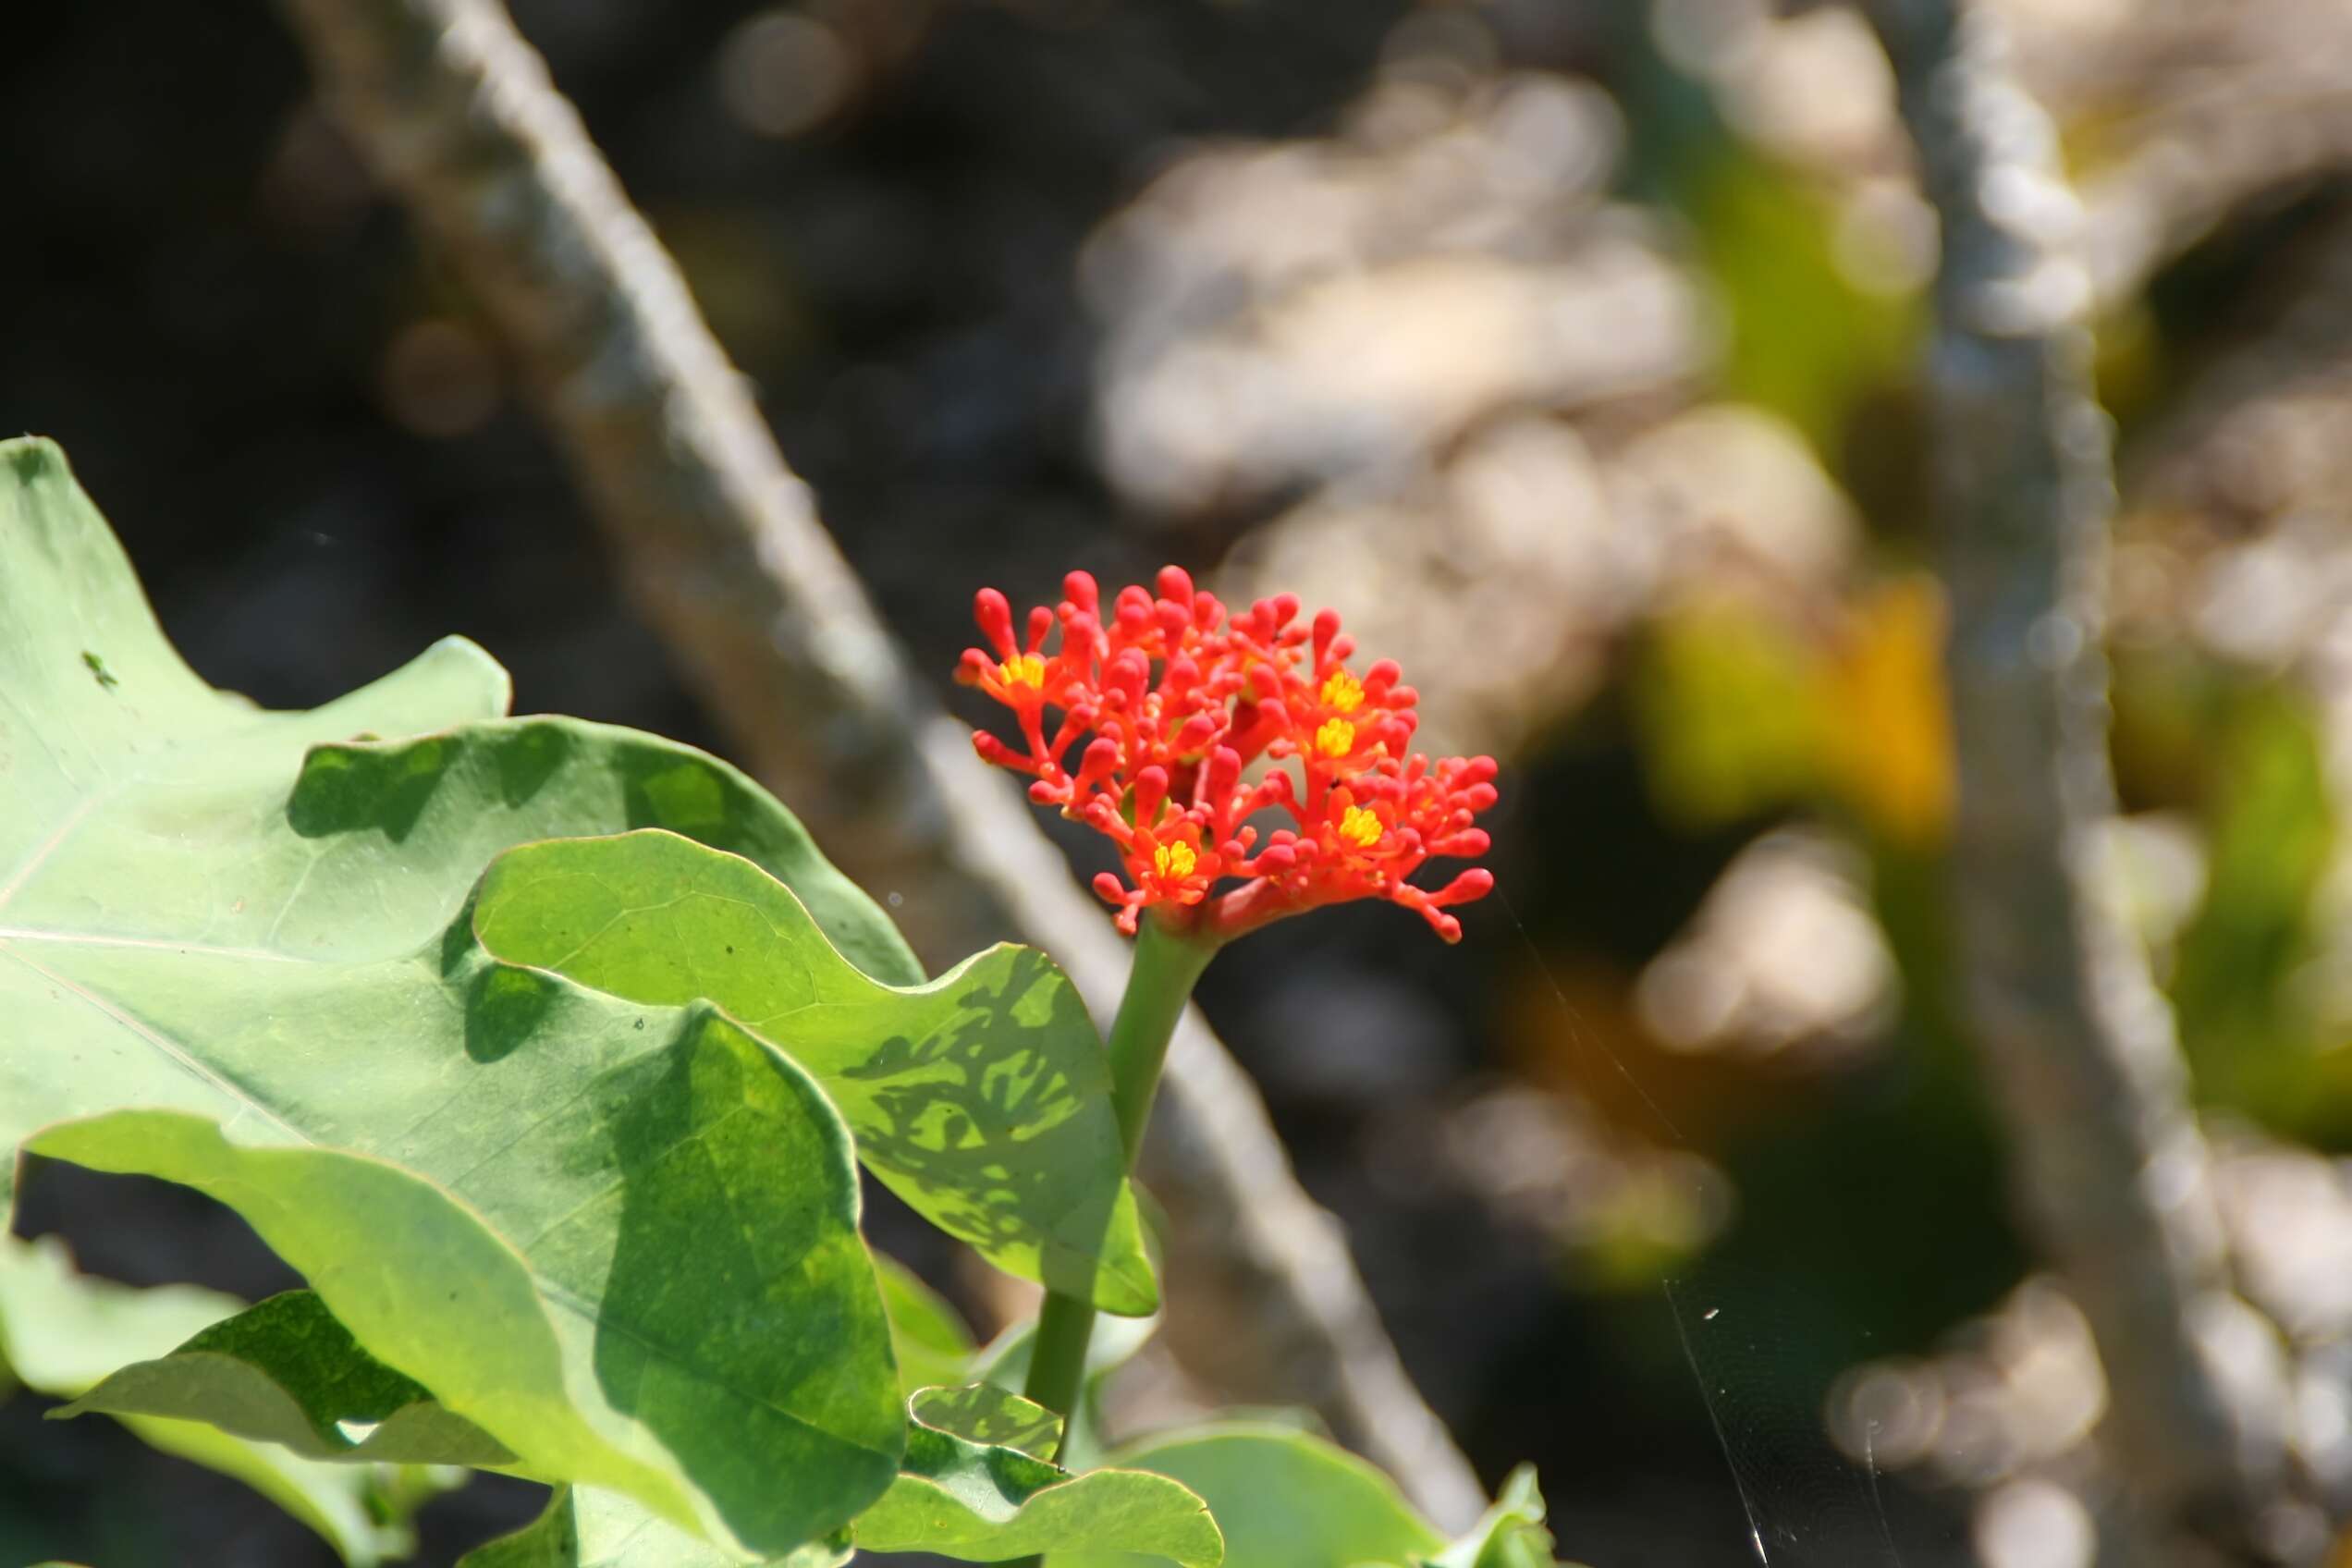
<box><xmin>1872</xmin><ymin>0</ymin><xmax>2282</xmax><ymax>1563</ymax></box>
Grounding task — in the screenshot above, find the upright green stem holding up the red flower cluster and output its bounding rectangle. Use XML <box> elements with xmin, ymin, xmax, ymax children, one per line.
<box><xmin>1021</xmin><ymin>919</ymin><xmax>1216</xmax><ymax>1446</ymax></box>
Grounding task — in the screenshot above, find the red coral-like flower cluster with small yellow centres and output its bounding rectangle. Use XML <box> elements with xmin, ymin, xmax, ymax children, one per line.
<box><xmin>957</xmin><ymin>567</ymin><xmax>1496</xmax><ymax>943</ymax></box>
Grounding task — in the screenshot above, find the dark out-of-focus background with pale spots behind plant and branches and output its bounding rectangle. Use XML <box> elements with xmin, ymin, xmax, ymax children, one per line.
<box><xmin>0</xmin><ymin>0</ymin><xmax>2352</xmax><ymax>1568</ymax></box>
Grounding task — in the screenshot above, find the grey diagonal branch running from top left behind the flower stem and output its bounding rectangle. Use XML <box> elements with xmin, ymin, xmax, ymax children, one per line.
<box><xmin>282</xmin><ymin>0</ymin><xmax>1482</xmax><ymax>1528</ymax></box>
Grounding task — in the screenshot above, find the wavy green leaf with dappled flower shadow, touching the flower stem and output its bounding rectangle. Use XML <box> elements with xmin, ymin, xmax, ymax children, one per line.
<box><xmin>475</xmin><ymin>832</ymin><xmax>1158</xmax><ymax>1314</ymax></box>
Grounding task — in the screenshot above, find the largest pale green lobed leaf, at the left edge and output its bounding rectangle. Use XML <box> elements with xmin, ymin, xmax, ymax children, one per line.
<box><xmin>0</xmin><ymin>442</ymin><xmax>915</xmax><ymax>1554</ymax></box>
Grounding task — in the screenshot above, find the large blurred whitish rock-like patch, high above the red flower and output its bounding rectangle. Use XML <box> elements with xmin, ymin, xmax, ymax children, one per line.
<box><xmin>1082</xmin><ymin>73</ymin><xmax>1705</xmax><ymax>517</ymax></box>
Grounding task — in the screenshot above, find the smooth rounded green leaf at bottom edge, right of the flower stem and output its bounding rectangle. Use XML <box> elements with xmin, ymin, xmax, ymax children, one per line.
<box><xmin>1049</xmin><ymin>1425</ymin><xmax>1444</xmax><ymax>1568</ymax></box>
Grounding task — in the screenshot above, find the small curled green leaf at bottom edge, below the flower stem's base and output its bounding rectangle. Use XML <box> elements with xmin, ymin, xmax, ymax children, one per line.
<box><xmin>851</xmin><ymin>1401</ymin><xmax>1225</xmax><ymax>1568</ymax></box>
